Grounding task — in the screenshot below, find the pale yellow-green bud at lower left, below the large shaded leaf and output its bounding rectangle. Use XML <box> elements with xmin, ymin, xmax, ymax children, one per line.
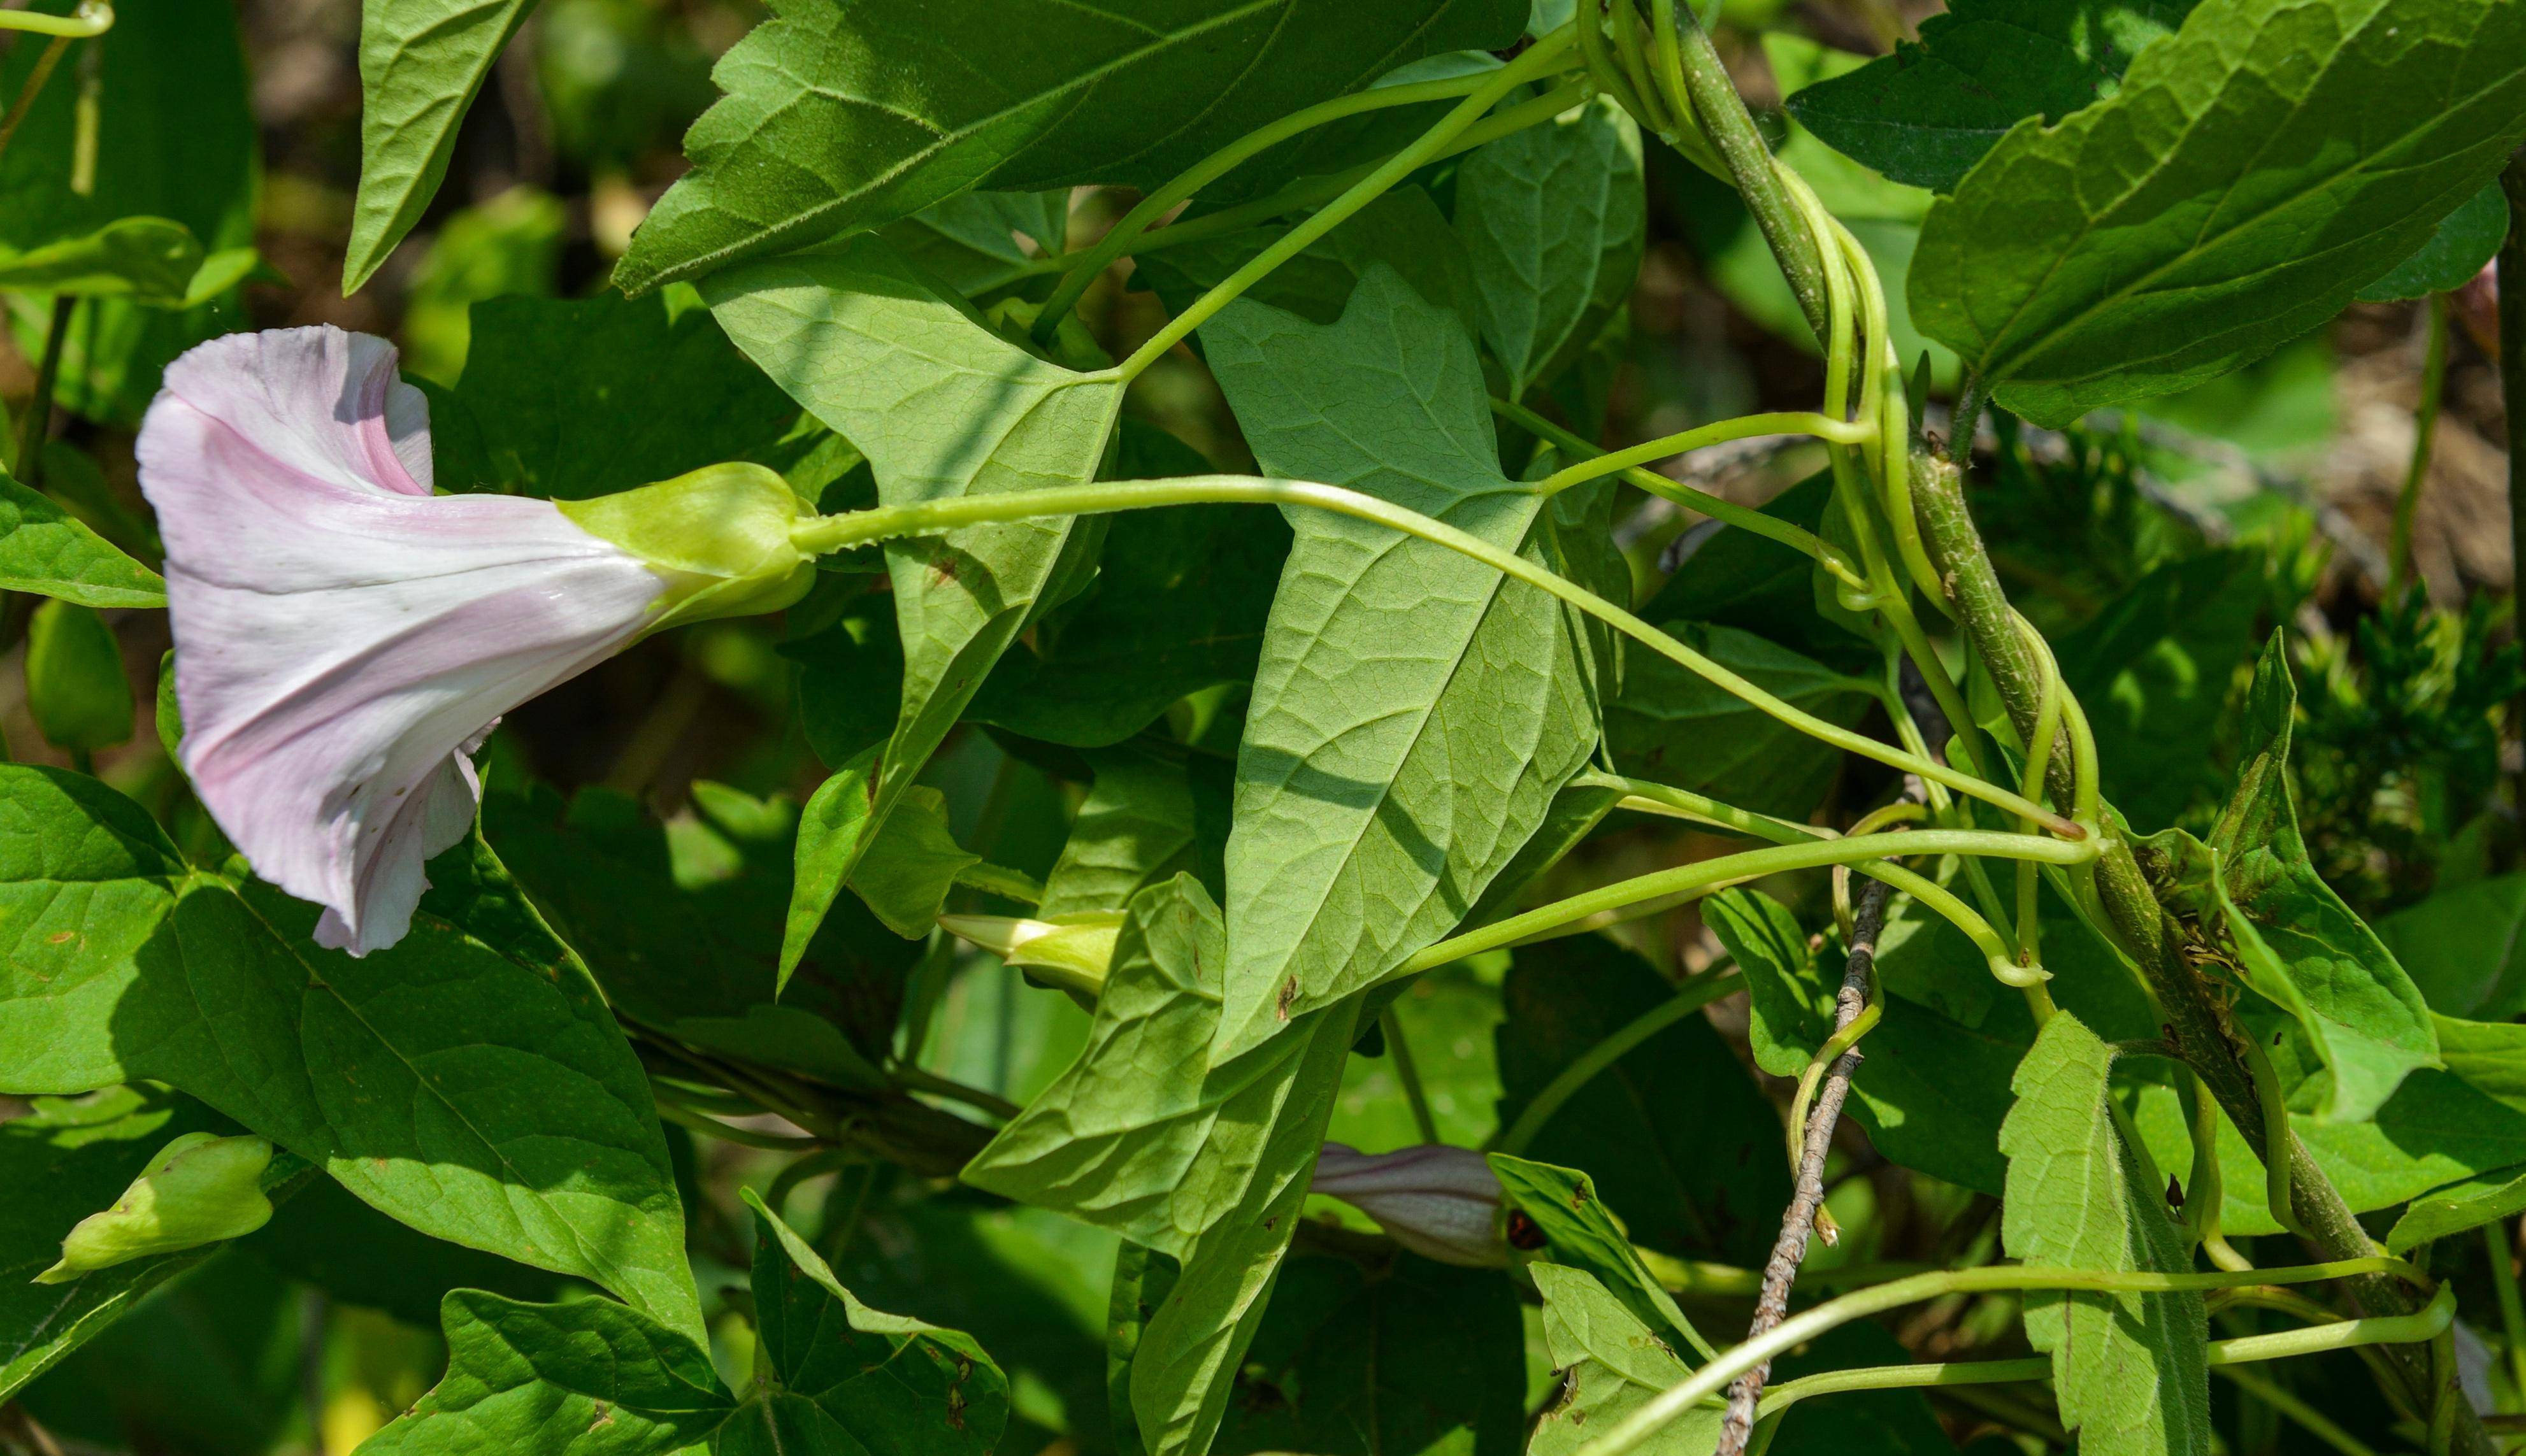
<box><xmin>36</xmin><ymin>1133</ymin><xmax>273</xmax><ymax>1285</ymax></box>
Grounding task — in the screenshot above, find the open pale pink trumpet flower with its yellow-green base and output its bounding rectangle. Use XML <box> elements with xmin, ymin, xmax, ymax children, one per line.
<box><xmin>136</xmin><ymin>325</ymin><xmax>814</xmax><ymax>954</ymax></box>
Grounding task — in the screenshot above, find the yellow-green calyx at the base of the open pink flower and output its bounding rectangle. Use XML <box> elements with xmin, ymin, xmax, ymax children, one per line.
<box><xmin>553</xmin><ymin>462</ymin><xmax>816</xmax><ymax>631</ymax></box>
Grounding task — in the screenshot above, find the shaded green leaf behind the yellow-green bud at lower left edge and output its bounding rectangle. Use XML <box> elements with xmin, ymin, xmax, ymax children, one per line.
<box><xmin>0</xmin><ymin>1088</ymin><xmax>233</xmax><ymax>1401</ymax></box>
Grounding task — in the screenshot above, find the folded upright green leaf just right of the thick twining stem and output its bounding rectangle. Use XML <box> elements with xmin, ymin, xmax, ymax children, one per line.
<box><xmin>2149</xmin><ymin>633</ymin><xmax>2440</xmax><ymax>1123</ymax></box>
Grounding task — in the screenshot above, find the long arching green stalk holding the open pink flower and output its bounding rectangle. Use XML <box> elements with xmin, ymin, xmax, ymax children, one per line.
<box><xmin>791</xmin><ymin>476</ymin><xmax>2092</xmax><ymax>832</ymax></box>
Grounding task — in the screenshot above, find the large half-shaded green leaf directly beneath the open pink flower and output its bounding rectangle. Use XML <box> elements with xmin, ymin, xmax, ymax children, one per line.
<box><xmin>0</xmin><ymin>764</ymin><xmax>700</xmax><ymax>1327</ymax></box>
